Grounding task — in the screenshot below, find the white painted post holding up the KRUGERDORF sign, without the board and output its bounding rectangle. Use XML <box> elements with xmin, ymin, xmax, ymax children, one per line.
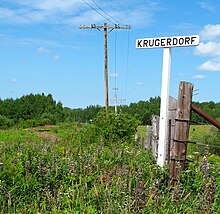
<box><xmin>157</xmin><ymin>48</ymin><xmax>171</xmax><ymax>167</ymax></box>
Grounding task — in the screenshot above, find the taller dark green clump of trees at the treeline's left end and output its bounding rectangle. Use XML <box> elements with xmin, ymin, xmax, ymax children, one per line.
<box><xmin>0</xmin><ymin>94</ymin><xmax>64</xmax><ymax>127</ymax></box>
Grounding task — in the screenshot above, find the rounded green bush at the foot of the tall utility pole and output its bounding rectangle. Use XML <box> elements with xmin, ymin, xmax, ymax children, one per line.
<box><xmin>94</xmin><ymin>111</ymin><xmax>139</xmax><ymax>143</ymax></box>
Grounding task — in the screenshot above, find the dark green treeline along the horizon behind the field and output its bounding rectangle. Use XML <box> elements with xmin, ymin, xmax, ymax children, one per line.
<box><xmin>0</xmin><ymin>94</ymin><xmax>220</xmax><ymax>129</ymax></box>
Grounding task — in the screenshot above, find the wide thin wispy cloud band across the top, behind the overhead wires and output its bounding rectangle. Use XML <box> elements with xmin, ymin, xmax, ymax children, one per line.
<box><xmin>0</xmin><ymin>0</ymin><xmax>161</xmax><ymax>26</ymax></box>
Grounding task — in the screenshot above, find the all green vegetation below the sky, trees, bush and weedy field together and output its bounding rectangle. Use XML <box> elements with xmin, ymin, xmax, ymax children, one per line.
<box><xmin>0</xmin><ymin>94</ymin><xmax>220</xmax><ymax>214</ymax></box>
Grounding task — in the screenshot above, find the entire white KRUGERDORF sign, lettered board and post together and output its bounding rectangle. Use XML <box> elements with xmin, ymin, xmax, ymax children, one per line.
<box><xmin>136</xmin><ymin>35</ymin><xmax>199</xmax><ymax>167</ymax></box>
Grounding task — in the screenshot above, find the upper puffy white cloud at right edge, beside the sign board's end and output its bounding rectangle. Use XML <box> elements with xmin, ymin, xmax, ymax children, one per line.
<box><xmin>199</xmin><ymin>24</ymin><xmax>220</xmax><ymax>40</ymax></box>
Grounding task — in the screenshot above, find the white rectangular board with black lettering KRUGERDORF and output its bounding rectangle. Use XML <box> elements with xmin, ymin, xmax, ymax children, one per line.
<box><xmin>136</xmin><ymin>35</ymin><xmax>199</xmax><ymax>48</ymax></box>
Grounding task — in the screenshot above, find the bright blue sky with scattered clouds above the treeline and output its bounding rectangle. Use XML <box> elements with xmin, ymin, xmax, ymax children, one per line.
<box><xmin>0</xmin><ymin>0</ymin><xmax>220</xmax><ymax>108</ymax></box>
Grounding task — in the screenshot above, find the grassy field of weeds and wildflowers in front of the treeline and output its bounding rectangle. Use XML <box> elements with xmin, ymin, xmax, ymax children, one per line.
<box><xmin>0</xmin><ymin>124</ymin><xmax>220</xmax><ymax>214</ymax></box>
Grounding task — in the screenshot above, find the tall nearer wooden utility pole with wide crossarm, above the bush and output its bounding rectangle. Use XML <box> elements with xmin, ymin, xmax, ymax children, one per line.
<box><xmin>79</xmin><ymin>23</ymin><xmax>131</xmax><ymax>111</ymax></box>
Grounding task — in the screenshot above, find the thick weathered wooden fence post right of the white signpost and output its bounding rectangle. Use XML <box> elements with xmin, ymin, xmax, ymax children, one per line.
<box><xmin>170</xmin><ymin>82</ymin><xmax>193</xmax><ymax>185</ymax></box>
